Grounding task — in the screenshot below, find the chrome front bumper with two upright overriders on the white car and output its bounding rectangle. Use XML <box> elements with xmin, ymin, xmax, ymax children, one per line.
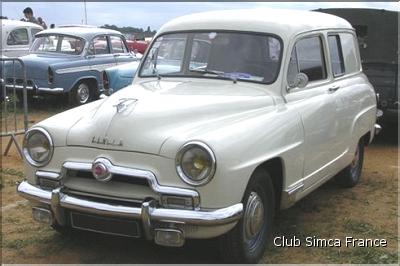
<box><xmin>17</xmin><ymin>181</ymin><xmax>243</xmax><ymax>245</ymax></box>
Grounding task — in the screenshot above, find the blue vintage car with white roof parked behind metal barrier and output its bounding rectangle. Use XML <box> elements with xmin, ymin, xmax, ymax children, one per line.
<box><xmin>4</xmin><ymin>27</ymin><xmax>139</xmax><ymax>105</ymax></box>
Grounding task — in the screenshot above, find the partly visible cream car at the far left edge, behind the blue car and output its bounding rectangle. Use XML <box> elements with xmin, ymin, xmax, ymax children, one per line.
<box><xmin>1</xmin><ymin>19</ymin><xmax>43</xmax><ymax>57</ymax></box>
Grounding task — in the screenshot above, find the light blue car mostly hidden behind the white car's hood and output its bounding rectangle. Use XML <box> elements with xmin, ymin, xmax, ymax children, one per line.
<box><xmin>103</xmin><ymin>61</ymin><xmax>140</xmax><ymax>95</ymax></box>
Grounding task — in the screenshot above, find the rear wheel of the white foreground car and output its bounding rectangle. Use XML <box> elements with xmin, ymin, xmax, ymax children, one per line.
<box><xmin>335</xmin><ymin>141</ymin><xmax>364</xmax><ymax>188</ymax></box>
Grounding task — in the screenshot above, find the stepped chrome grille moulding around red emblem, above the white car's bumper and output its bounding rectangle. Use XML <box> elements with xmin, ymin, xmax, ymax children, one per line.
<box><xmin>63</xmin><ymin>158</ymin><xmax>200</xmax><ymax>208</ymax></box>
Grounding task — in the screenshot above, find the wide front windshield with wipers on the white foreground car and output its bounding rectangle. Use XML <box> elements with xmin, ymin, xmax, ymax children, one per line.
<box><xmin>140</xmin><ymin>31</ymin><xmax>281</xmax><ymax>83</ymax></box>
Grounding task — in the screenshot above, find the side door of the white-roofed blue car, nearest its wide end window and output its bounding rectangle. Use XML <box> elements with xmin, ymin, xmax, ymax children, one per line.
<box><xmin>86</xmin><ymin>35</ymin><xmax>116</xmax><ymax>73</ymax></box>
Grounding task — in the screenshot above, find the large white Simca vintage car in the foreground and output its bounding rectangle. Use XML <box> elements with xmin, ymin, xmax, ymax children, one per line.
<box><xmin>18</xmin><ymin>9</ymin><xmax>379</xmax><ymax>263</ymax></box>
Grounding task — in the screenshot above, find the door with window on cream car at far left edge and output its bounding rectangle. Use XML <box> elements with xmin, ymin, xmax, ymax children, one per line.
<box><xmin>3</xmin><ymin>27</ymin><xmax>29</xmax><ymax>57</ymax></box>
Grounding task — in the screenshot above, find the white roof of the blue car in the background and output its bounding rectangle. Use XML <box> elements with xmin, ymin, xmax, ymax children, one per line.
<box><xmin>36</xmin><ymin>26</ymin><xmax>122</xmax><ymax>39</ymax></box>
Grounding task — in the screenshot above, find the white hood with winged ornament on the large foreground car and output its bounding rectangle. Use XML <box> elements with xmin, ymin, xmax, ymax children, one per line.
<box><xmin>67</xmin><ymin>78</ymin><xmax>274</xmax><ymax>154</ymax></box>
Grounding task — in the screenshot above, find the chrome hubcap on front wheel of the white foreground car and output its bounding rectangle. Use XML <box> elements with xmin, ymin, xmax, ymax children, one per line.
<box><xmin>244</xmin><ymin>191</ymin><xmax>264</xmax><ymax>240</ymax></box>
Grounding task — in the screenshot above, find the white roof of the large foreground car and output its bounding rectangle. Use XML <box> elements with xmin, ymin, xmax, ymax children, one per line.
<box><xmin>157</xmin><ymin>8</ymin><xmax>352</xmax><ymax>38</ymax></box>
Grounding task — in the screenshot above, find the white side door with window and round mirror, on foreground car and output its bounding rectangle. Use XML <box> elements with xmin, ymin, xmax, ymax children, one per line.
<box><xmin>285</xmin><ymin>33</ymin><xmax>340</xmax><ymax>189</ymax></box>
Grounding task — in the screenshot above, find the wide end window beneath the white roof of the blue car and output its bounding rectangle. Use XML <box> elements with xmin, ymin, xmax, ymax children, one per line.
<box><xmin>31</xmin><ymin>35</ymin><xmax>85</xmax><ymax>55</ymax></box>
